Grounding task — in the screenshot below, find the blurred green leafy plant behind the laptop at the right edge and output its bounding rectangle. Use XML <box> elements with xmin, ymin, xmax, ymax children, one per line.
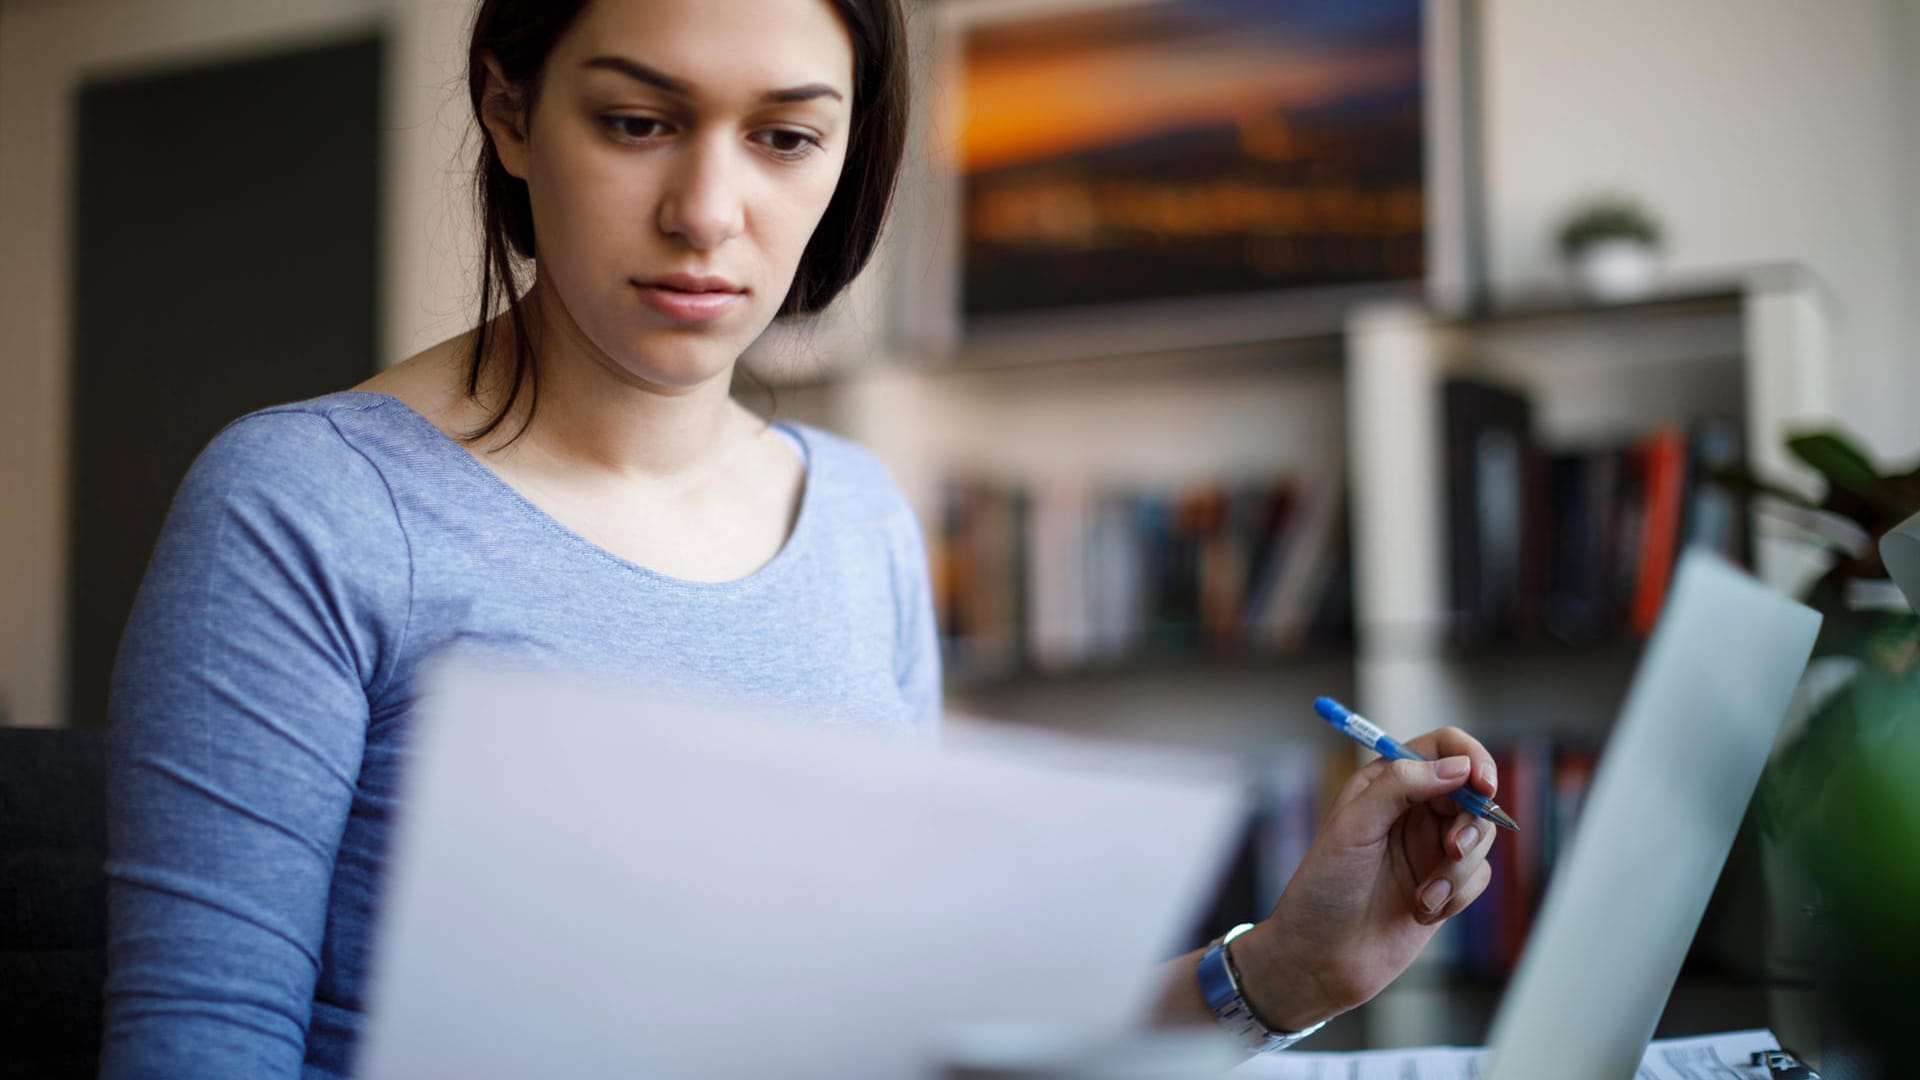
<box><xmin>1720</xmin><ymin>430</ymin><xmax>1920</xmax><ymax>1014</ymax></box>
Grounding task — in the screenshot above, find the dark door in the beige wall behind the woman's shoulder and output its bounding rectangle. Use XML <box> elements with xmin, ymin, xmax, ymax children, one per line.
<box><xmin>67</xmin><ymin>37</ymin><xmax>380</xmax><ymax>726</ymax></box>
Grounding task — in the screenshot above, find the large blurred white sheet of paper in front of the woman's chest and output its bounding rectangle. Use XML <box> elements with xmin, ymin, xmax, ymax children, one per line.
<box><xmin>355</xmin><ymin>657</ymin><xmax>1246</xmax><ymax>1080</ymax></box>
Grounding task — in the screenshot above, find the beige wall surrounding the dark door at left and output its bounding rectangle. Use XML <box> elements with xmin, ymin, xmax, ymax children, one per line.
<box><xmin>0</xmin><ymin>0</ymin><xmax>476</xmax><ymax>726</ymax></box>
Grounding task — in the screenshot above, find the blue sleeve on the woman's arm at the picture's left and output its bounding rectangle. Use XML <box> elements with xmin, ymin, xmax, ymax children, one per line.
<box><xmin>102</xmin><ymin>411</ymin><xmax>411</xmax><ymax>1078</ymax></box>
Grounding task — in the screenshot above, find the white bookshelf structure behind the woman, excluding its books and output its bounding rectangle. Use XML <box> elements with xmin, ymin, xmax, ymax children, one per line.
<box><xmin>753</xmin><ymin>255</ymin><xmax>1830</xmax><ymax>1047</ymax></box>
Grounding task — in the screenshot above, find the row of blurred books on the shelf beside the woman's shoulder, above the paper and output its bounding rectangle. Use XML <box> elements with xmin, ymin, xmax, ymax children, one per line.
<box><xmin>929</xmin><ymin>475</ymin><xmax>1352</xmax><ymax>676</ymax></box>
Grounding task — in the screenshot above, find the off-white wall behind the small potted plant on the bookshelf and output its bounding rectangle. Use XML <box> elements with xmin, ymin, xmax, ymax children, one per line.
<box><xmin>1484</xmin><ymin>0</ymin><xmax>1920</xmax><ymax>457</ymax></box>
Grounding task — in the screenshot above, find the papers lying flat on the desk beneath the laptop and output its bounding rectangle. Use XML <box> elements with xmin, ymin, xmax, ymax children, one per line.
<box><xmin>1233</xmin><ymin>1030</ymin><xmax>1780</xmax><ymax>1080</ymax></box>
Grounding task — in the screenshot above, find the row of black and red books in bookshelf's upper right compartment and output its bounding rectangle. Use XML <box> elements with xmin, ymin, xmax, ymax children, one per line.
<box><xmin>1442</xmin><ymin>379</ymin><xmax>1751</xmax><ymax>644</ymax></box>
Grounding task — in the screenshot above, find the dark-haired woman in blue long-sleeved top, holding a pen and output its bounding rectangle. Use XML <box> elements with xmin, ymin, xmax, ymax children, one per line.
<box><xmin>104</xmin><ymin>0</ymin><xmax>1492</xmax><ymax>1076</ymax></box>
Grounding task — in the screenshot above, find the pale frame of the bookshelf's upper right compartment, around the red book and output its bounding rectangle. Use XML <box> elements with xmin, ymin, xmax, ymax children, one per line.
<box><xmin>1348</xmin><ymin>267</ymin><xmax>1830</xmax><ymax>736</ymax></box>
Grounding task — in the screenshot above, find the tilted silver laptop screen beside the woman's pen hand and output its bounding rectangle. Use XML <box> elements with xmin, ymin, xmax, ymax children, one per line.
<box><xmin>1488</xmin><ymin>552</ymin><xmax>1820</xmax><ymax>1080</ymax></box>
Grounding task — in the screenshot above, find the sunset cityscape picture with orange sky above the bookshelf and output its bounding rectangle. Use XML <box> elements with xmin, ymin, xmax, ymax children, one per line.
<box><xmin>948</xmin><ymin>0</ymin><xmax>1427</xmax><ymax>321</ymax></box>
